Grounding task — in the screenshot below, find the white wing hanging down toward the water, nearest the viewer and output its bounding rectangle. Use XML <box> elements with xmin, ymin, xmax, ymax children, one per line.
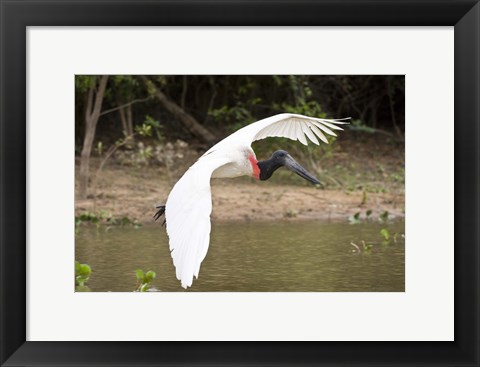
<box><xmin>165</xmin><ymin>156</ymin><xmax>229</xmax><ymax>288</ymax></box>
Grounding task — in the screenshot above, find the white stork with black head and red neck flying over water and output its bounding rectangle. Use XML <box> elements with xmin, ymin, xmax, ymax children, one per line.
<box><xmin>155</xmin><ymin>113</ymin><xmax>349</xmax><ymax>288</ymax></box>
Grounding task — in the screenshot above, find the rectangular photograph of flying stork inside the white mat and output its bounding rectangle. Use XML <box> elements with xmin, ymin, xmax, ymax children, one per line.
<box><xmin>74</xmin><ymin>75</ymin><xmax>406</xmax><ymax>292</ymax></box>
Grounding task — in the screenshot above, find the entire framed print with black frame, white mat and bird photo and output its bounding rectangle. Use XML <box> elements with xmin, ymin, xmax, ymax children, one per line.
<box><xmin>0</xmin><ymin>0</ymin><xmax>480</xmax><ymax>366</ymax></box>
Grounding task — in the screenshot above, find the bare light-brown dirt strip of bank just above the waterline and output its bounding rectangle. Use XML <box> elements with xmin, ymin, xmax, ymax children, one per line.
<box><xmin>75</xmin><ymin>166</ymin><xmax>404</xmax><ymax>224</ymax></box>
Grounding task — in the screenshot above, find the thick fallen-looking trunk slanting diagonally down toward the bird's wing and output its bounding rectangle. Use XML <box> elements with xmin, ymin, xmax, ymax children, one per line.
<box><xmin>140</xmin><ymin>75</ymin><xmax>216</xmax><ymax>144</ymax></box>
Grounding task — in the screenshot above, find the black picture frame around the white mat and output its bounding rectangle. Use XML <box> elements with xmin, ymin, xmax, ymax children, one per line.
<box><xmin>0</xmin><ymin>0</ymin><xmax>480</xmax><ymax>366</ymax></box>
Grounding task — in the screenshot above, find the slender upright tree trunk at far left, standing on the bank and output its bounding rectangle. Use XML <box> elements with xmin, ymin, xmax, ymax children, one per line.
<box><xmin>79</xmin><ymin>75</ymin><xmax>108</xmax><ymax>199</ymax></box>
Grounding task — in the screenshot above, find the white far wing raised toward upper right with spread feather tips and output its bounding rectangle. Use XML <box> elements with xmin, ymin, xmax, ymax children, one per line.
<box><xmin>205</xmin><ymin>113</ymin><xmax>350</xmax><ymax>155</ymax></box>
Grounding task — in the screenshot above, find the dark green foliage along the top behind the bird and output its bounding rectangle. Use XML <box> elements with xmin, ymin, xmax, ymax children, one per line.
<box><xmin>76</xmin><ymin>75</ymin><xmax>405</xmax><ymax>153</ymax></box>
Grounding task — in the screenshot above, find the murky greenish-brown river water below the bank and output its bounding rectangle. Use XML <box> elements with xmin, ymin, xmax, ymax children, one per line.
<box><xmin>75</xmin><ymin>221</ymin><xmax>405</xmax><ymax>292</ymax></box>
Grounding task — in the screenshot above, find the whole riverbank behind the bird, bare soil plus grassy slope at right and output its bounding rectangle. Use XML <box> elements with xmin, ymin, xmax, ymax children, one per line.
<box><xmin>75</xmin><ymin>134</ymin><xmax>405</xmax><ymax>224</ymax></box>
